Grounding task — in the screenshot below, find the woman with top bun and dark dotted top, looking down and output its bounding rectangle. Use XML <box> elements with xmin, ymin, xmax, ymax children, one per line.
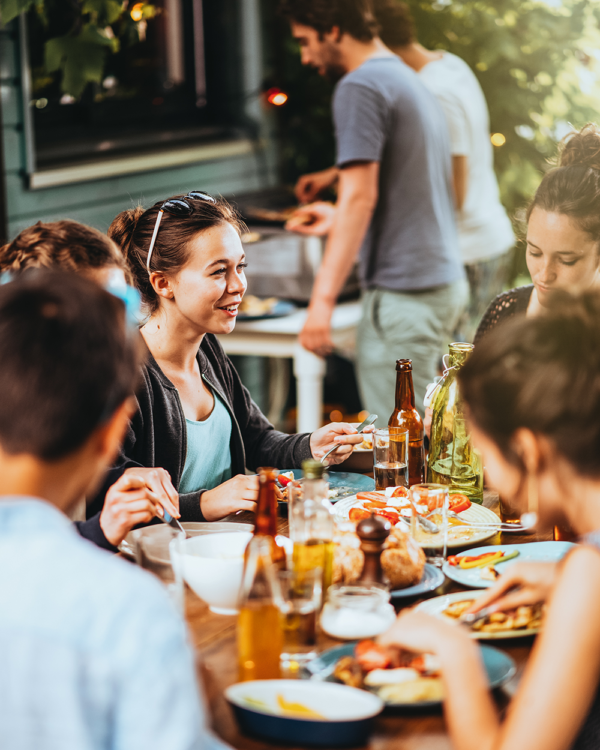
<box><xmin>475</xmin><ymin>124</ymin><xmax>600</xmax><ymax>344</ymax></box>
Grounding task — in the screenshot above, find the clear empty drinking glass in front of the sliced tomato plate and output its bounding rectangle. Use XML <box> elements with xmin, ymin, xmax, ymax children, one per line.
<box><xmin>410</xmin><ymin>484</ymin><xmax>450</xmax><ymax>568</ymax></box>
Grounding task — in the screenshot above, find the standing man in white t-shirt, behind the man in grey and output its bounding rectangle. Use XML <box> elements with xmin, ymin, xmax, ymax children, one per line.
<box><xmin>290</xmin><ymin>0</ymin><xmax>515</xmax><ymax>341</ymax></box>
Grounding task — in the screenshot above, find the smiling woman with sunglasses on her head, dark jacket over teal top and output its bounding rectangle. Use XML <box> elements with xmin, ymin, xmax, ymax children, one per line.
<box><xmin>94</xmin><ymin>191</ymin><xmax>361</xmax><ymax>521</ymax></box>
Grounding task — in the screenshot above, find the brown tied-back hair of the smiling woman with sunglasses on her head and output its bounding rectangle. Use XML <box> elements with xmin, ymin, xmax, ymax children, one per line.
<box><xmin>108</xmin><ymin>195</ymin><xmax>246</xmax><ymax>313</ymax></box>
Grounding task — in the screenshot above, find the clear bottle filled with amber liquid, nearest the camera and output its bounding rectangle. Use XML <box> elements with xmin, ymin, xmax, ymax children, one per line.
<box><xmin>237</xmin><ymin>535</ymin><xmax>283</xmax><ymax>682</ymax></box>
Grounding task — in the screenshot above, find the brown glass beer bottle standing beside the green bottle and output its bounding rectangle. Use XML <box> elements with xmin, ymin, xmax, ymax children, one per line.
<box><xmin>388</xmin><ymin>359</ymin><xmax>425</xmax><ymax>487</ymax></box>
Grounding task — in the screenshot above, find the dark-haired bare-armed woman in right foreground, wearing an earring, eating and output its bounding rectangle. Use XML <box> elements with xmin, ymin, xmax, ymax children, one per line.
<box><xmin>382</xmin><ymin>292</ymin><xmax>600</xmax><ymax>750</ymax></box>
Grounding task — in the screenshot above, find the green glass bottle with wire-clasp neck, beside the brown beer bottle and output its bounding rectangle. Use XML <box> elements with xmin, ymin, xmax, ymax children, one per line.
<box><xmin>427</xmin><ymin>343</ymin><xmax>483</xmax><ymax>504</ymax></box>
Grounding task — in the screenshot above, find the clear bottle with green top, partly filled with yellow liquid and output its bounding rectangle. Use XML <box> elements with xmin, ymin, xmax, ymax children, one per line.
<box><xmin>292</xmin><ymin>459</ymin><xmax>334</xmax><ymax>592</ymax></box>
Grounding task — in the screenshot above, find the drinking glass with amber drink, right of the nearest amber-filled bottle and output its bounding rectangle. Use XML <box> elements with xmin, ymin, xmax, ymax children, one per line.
<box><xmin>275</xmin><ymin>568</ymin><xmax>323</xmax><ymax>673</ymax></box>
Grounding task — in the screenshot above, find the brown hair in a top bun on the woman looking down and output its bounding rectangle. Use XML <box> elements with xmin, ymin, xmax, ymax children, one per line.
<box><xmin>527</xmin><ymin>123</ymin><xmax>600</xmax><ymax>243</ymax></box>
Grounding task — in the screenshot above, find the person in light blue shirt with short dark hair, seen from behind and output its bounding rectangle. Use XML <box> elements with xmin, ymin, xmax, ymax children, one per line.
<box><xmin>0</xmin><ymin>271</ymin><xmax>227</xmax><ymax>750</ymax></box>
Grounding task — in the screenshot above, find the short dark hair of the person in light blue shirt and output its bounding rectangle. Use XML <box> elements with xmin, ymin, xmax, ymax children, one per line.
<box><xmin>0</xmin><ymin>269</ymin><xmax>139</xmax><ymax>461</ymax></box>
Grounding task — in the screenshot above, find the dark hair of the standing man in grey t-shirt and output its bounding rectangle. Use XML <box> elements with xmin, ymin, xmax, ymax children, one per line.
<box><xmin>279</xmin><ymin>0</ymin><xmax>379</xmax><ymax>42</ymax></box>
